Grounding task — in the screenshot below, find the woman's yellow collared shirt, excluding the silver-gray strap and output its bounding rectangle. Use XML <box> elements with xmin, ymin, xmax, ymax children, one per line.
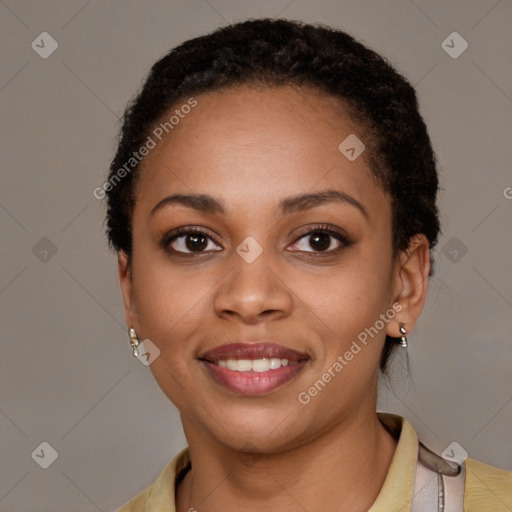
<box><xmin>118</xmin><ymin>412</ymin><xmax>512</xmax><ymax>512</ymax></box>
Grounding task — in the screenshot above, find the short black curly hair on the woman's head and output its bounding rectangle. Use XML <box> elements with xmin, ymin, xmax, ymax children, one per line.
<box><xmin>104</xmin><ymin>19</ymin><xmax>440</xmax><ymax>373</ymax></box>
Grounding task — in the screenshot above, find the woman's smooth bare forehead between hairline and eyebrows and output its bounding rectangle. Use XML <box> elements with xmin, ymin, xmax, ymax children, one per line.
<box><xmin>137</xmin><ymin>86</ymin><xmax>384</xmax><ymax>217</ymax></box>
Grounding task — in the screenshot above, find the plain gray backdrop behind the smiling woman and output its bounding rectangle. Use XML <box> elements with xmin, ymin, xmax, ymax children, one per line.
<box><xmin>0</xmin><ymin>0</ymin><xmax>512</xmax><ymax>512</ymax></box>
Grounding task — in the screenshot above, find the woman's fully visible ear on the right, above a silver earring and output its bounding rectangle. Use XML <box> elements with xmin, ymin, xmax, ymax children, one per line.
<box><xmin>386</xmin><ymin>234</ymin><xmax>430</xmax><ymax>338</ymax></box>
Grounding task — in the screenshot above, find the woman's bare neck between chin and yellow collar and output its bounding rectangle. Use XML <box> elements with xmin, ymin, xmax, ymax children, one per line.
<box><xmin>176</xmin><ymin>411</ymin><xmax>396</xmax><ymax>512</ymax></box>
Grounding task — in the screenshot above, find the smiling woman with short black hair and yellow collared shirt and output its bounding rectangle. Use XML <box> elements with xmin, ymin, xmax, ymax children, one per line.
<box><xmin>104</xmin><ymin>20</ymin><xmax>512</xmax><ymax>512</ymax></box>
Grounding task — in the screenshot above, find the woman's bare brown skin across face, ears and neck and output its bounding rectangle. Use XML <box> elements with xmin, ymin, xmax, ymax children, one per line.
<box><xmin>119</xmin><ymin>86</ymin><xmax>430</xmax><ymax>512</ymax></box>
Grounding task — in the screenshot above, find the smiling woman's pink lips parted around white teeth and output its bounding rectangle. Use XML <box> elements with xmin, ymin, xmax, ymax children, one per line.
<box><xmin>199</xmin><ymin>342</ymin><xmax>309</xmax><ymax>396</ymax></box>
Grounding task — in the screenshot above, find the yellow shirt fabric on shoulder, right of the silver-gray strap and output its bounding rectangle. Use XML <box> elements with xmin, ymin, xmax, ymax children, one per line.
<box><xmin>464</xmin><ymin>459</ymin><xmax>512</xmax><ymax>512</ymax></box>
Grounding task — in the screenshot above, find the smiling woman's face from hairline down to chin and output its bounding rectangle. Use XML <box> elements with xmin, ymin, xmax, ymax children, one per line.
<box><xmin>120</xmin><ymin>87</ymin><xmax>420</xmax><ymax>451</ymax></box>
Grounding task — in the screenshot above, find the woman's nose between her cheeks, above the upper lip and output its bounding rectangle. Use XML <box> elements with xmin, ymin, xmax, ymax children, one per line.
<box><xmin>214</xmin><ymin>247</ymin><xmax>293</xmax><ymax>324</ymax></box>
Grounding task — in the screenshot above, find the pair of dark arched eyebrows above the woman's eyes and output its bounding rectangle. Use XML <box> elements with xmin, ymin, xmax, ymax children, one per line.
<box><xmin>150</xmin><ymin>189</ymin><xmax>369</xmax><ymax>219</ymax></box>
